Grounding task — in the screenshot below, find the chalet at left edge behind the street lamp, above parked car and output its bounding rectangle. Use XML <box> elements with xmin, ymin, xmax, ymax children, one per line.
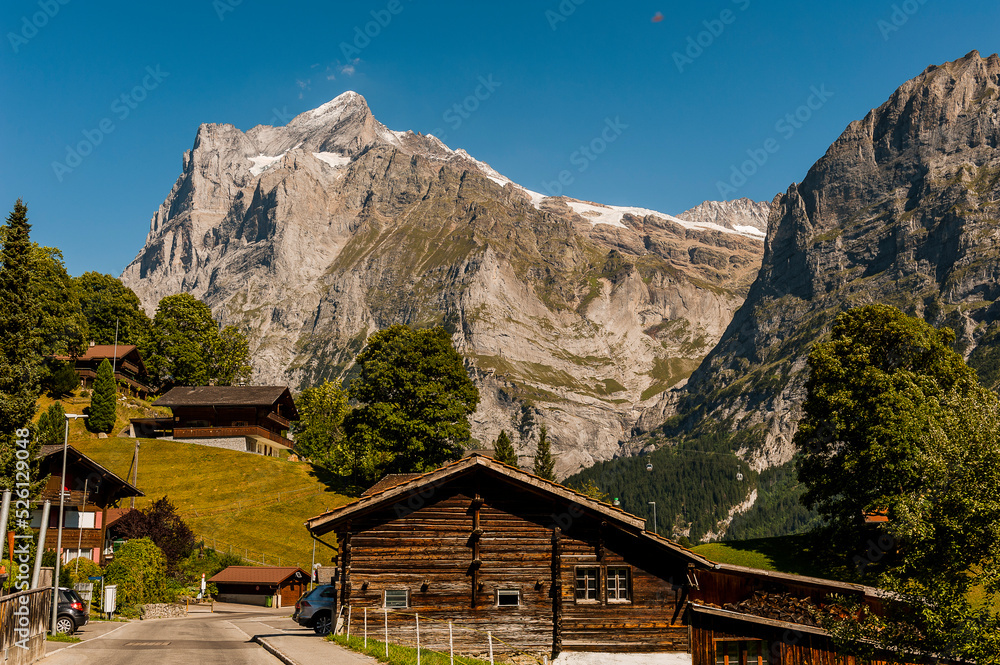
<box><xmin>31</xmin><ymin>445</ymin><xmax>145</xmax><ymax>565</ymax></box>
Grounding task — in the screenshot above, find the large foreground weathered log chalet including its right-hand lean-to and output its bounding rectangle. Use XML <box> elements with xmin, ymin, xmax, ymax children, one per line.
<box><xmin>306</xmin><ymin>456</ymin><xmax>956</xmax><ymax>665</ymax></box>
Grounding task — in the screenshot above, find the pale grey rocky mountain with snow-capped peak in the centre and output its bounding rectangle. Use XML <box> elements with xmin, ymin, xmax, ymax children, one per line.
<box><xmin>122</xmin><ymin>93</ymin><xmax>767</xmax><ymax>477</ymax></box>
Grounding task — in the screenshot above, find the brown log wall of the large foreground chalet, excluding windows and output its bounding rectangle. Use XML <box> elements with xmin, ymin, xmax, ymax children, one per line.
<box><xmin>338</xmin><ymin>477</ymin><xmax>689</xmax><ymax>656</ymax></box>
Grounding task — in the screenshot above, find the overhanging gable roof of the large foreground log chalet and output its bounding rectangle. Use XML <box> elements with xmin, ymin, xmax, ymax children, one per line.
<box><xmin>305</xmin><ymin>455</ymin><xmax>714</xmax><ymax>568</ymax></box>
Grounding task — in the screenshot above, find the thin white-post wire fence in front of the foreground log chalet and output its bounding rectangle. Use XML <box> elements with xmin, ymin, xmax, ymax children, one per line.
<box><xmin>335</xmin><ymin>605</ymin><xmax>548</xmax><ymax>665</ymax></box>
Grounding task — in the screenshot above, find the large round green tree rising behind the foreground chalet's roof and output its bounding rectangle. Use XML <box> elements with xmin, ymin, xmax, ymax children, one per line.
<box><xmin>345</xmin><ymin>325</ymin><xmax>479</xmax><ymax>480</ymax></box>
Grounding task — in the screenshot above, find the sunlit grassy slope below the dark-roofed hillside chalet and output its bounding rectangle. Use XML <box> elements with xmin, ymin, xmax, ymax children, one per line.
<box><xmin>70</xmin><ymin>435</ymin><xmax>351</xmax><ymax>569</ymax></box>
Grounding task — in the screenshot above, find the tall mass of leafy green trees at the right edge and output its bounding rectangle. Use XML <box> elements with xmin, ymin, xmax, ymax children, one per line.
<box><xmin>794</xmin><ymin>305</ymin><xmax>1000</xmax><ymax>662</ymax></box>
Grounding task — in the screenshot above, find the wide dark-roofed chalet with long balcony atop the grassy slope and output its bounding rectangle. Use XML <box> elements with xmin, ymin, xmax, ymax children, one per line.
<box><xmin>132</xmin><ymin>386</ymin><xmax>299</xmax><ymax>457</ymax></box>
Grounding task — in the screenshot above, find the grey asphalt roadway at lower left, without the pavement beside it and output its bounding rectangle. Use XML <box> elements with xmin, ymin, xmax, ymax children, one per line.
<box><xmin>41</xmin><ymin>612</ymin><xmax>281</xmax><ymax>665</ymax></box>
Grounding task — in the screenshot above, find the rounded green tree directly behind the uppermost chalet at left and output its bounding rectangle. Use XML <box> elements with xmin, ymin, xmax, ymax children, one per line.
<box><xmin>76</xmin><ymin>272</ymin><xmax>152</xmax><ymax>348</ymax></box>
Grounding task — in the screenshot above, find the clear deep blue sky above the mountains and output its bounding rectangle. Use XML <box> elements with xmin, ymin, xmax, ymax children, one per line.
<box><xmin>0</xmin><ymin>0</ymin><xmax>1000</xmax><ymax>275</ymax></box>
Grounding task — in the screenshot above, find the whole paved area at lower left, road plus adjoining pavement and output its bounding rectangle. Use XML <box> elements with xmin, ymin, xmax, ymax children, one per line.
<box><xmin>41</xmin><ymin>603</ymin><xmax>377</xmax><ymax>665</ymax></box>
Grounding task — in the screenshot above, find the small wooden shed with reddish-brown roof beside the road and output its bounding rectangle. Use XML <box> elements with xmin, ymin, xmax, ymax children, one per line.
<box><xmin>208</xmin><ymin>566</ymin><xmax>309</xmax><ymax>607</ymax></box>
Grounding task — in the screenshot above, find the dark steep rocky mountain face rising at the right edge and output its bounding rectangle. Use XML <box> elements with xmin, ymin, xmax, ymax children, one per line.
<box><xmin>660</xmin><ymin>52</ymin><xmax>1000</xmax><ymax>469</ymax></box>
